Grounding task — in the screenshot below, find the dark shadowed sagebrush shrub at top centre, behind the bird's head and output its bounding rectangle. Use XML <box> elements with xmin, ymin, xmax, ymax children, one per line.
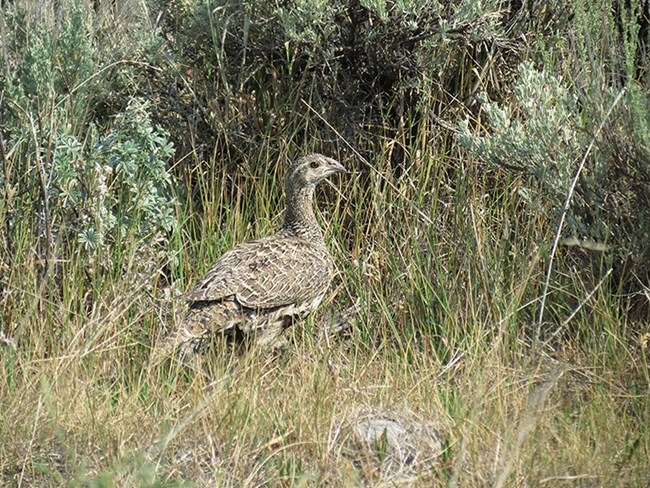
<box><xmin>154</xmin><ymin>0</ymin><xmax>509</xmax><ymax>163</ymax></box>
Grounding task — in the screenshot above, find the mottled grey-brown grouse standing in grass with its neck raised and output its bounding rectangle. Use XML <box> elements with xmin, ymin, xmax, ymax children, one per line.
<box><xmin>160</xmin><ymin>154</ymin><xmax>346</xmax><ymax>359</ymax></box>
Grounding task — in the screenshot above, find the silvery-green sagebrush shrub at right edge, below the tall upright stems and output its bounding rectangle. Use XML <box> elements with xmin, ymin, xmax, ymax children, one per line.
<box><xmin>457</xmin><ymin>58</ymin><xmax>650</xmax><ymax>298</ymax></box>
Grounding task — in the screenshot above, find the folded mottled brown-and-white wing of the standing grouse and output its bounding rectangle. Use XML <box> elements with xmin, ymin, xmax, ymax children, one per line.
<box><xmin>186</xmin><ymin>239</ymin><xmax>333</xmax><ymax>309</ymax></box>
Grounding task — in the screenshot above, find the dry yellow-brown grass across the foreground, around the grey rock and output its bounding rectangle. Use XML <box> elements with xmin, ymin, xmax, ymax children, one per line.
<box><xmin>0</xmin><ymin>302</ymin><xmax>648</xmax><ymax>486</ymax></box>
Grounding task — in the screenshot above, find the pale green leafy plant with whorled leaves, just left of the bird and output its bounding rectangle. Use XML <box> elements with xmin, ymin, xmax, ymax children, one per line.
<box><xmin>76</xmin><ymin>99</ymin><xmax>177</xmax><ymax>264</ymax></box>
